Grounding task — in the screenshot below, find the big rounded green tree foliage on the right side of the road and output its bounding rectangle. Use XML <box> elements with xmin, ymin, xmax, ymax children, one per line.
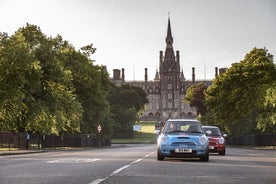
<box><xmin>206</xmin><ymin>48</ymin><xmax>276</xmax><ymax>135</ymax></box>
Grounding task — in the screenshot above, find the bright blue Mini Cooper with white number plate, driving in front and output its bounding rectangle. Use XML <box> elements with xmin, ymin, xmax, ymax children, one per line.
<box><xmin>157</xmin><ymin>119</ymin><xmax>209</xmax><ymax>161</ymax></box>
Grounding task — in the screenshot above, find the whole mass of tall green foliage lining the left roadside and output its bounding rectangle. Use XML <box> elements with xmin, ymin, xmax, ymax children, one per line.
<box><xmin>0</xmin><ymin>24</ymin><xmax>112</xmax><ymax>134</ymax></box>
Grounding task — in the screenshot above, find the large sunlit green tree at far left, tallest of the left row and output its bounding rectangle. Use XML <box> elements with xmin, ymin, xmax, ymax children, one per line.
<box><xmin>0</xmin><ymin>24</ymin><xmax>82</xmax><ymax>134</ymax></box>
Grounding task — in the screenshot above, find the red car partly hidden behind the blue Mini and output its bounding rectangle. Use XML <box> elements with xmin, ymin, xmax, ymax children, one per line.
<box><xmin>202</xmin><ymin>126</ymin><xmax>226</xmax><ymax>155</ymax></box>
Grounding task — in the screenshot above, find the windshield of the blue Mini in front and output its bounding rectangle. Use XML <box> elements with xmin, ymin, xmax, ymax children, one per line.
<box><xmin>163</xmin><ymin>121</ymin><xmax>202</xmax><ymax>133</ymax></box>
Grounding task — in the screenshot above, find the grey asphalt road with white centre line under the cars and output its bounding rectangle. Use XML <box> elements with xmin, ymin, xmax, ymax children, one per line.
<box><xmin>0</xmin><ymin>144</ymin><xmax>276</xmax><ymax>184</ymax></box>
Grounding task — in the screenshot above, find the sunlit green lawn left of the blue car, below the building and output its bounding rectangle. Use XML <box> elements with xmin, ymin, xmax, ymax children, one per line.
<box><xmin>111</xmin><ymin>121</ymin><xmax>156</xmax><ymax>144</ymax></box>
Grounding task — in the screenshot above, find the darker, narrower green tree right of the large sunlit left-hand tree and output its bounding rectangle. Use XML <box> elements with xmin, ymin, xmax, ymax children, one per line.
<box><xmin>58</xmin><ymin>43</ymin><xmax>113</xmax><ymax>136</ymax></box>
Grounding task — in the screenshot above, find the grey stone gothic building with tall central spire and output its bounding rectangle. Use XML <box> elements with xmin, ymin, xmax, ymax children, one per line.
<box><xmin>112</xmin><ymin>19</ymin><xmax>217</xmax><ymax>120</ymax></box>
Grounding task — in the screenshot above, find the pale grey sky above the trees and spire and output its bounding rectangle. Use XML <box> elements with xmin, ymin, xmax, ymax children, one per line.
<box><xmin>0</xmin><ymin>0</ymin><xmax>276</xmax><ymax>81</ymax></box>
